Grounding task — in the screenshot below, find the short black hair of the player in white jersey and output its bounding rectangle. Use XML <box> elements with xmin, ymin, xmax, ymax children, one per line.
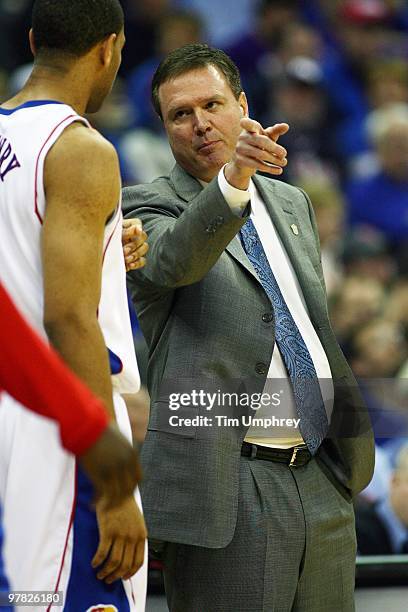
<box><xmin>32</xmin><ymin>0</ymin><xmax>124</xmax><ymax>57</ymax></box>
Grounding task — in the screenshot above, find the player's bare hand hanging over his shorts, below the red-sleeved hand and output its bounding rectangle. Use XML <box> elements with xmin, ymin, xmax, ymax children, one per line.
<box><xmin>92</xmin><ymin>495</ymin><xmax>147</xmax><ymax>584</ymax></box>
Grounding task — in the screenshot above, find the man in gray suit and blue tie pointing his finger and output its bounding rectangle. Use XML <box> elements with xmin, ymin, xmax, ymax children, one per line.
<box><xmin>123</xmin><ymin>45</ymin><xmax>373</xmax><ymax>612</ymax></box>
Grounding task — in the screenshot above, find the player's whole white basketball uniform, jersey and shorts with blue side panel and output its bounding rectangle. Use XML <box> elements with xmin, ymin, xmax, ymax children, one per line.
<box><xmin>0</xmin><ymin>101</ymin><xmax>147</xmax><ymax>612</ymax></box>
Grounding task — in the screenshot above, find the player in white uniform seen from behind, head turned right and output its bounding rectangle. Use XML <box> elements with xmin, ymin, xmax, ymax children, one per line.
<box><xmin>0</xmin><ymin>0</ymin><xmax>146</xmax><ymax>612</ymax></box>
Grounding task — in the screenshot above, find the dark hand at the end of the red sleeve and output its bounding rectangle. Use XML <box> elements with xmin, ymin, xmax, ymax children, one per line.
<box><xmin>79</xmin><ymin>422</ymin><xmax>142</xmax><ymax>508</ymax></box>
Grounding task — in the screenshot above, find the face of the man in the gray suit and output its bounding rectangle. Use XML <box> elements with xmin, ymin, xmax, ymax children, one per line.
<box><xmin>159</xmin><ymin>65</ymin><xmax>248</xmax><ymax>182</ymax></box>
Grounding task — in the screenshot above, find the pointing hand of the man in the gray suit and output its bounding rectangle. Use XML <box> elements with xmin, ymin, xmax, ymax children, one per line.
<box><xmin>225</xmin><ymin>117</ymin><xmax>289</xmax><ymax>189</ymax></box>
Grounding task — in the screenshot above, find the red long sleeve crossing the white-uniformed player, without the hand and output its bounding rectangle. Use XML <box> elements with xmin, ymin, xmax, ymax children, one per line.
<box><xmin>0</xmin><ymin>285</ymin><xmax>110</xmax><ymax>455</ymax></box>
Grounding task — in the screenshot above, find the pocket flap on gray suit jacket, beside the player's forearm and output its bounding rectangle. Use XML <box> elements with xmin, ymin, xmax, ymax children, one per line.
<box><xmin>147</xmin><ymin>400</ymin><xmax>200</xmax><ymax>438</ymax></box>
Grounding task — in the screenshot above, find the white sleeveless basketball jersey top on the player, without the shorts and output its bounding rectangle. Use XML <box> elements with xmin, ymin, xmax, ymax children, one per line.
<box><xmin>0</xmin><ymin>101</ymin><xmax>139</xmax><ymax>393</ymax></box>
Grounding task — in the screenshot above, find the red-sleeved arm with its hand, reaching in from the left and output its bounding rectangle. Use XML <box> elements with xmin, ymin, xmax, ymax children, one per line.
<box><xmin>0</xmin><ymin>284</ymin><xmax>140</xmax><ymax>505</ymax></box>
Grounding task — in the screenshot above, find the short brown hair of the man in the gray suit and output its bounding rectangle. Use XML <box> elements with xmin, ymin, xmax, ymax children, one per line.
<box><xmin>152</xmin><ymin>43</ymin><xmax>242</xmax><ymax>119</ymax></box>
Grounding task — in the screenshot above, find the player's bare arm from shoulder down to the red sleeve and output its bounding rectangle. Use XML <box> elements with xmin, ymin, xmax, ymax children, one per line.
<box><xmin>42</xmin><ymin>124</ymin><xmax>120</xmax><ymax>416</ymax></box>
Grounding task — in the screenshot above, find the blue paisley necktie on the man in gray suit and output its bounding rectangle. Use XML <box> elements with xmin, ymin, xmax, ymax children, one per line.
<box><xmin>240</xmin><ymin>218</ymin><xmax>328</xmax><ymax>454</ymax></box>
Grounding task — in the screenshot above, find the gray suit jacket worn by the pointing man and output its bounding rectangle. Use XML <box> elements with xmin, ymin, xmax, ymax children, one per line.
<box><xmin>123</xmin><ymin>165</ymin><xmax>373</xmax><ymax>548</ymax></box>
